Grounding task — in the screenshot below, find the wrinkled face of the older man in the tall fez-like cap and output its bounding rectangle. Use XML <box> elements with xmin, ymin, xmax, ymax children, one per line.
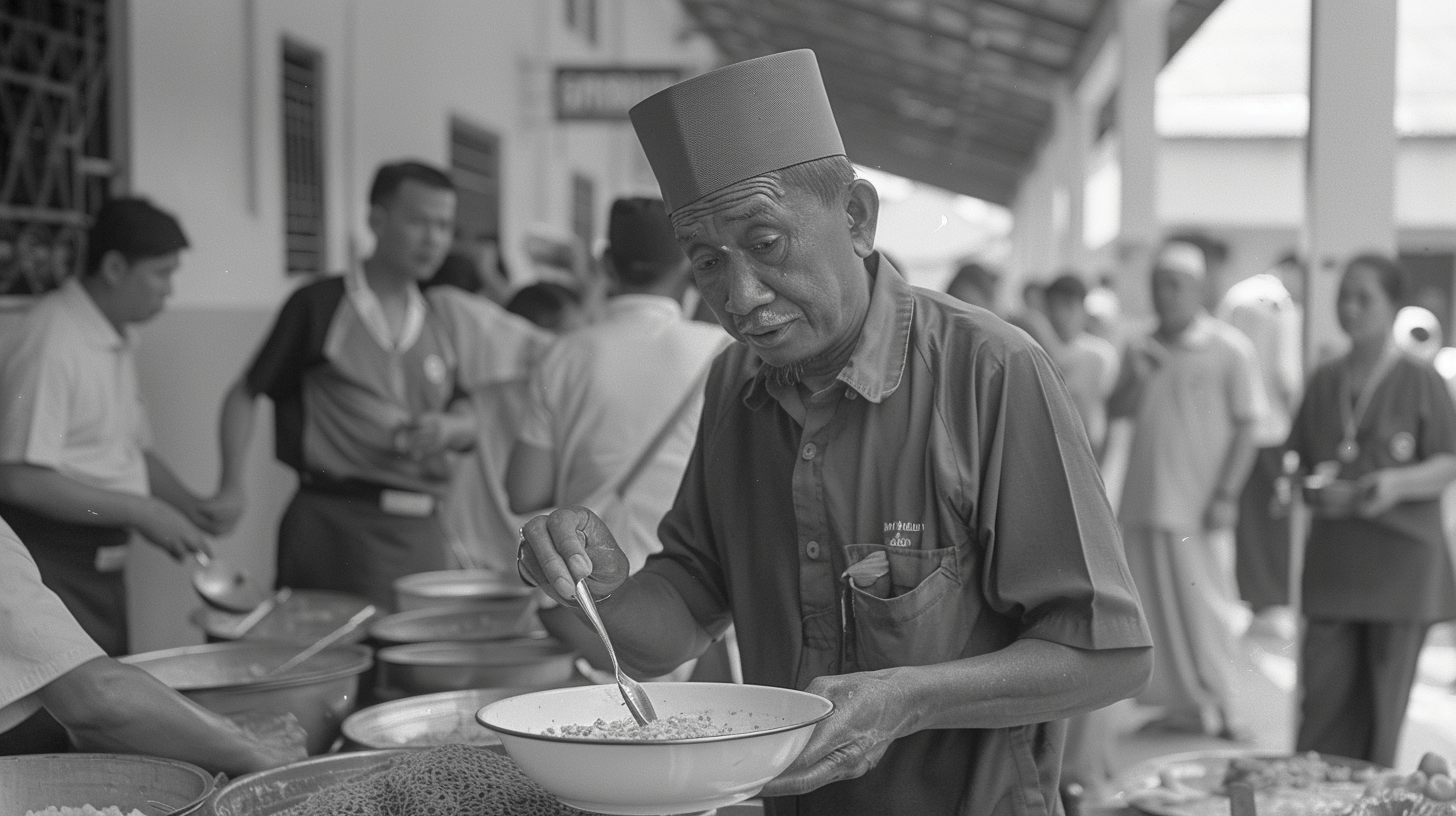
<box><xmin>673</xmin><ymin>176</ymin><xmax>878</xmax><ymax>367</ymax></box>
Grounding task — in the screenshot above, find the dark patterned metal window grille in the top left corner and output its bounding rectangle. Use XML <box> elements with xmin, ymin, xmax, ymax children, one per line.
<box><xmin>0</xmin><ymin>0</ymin><xmax>115</xmax><ymax>296</ymax></box>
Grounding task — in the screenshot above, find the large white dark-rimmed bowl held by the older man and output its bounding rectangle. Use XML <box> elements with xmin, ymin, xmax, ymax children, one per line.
<box><xmin>476</xmin><ymin>683</ymin><xmax>834</xmax><ymax>816</ymax></box>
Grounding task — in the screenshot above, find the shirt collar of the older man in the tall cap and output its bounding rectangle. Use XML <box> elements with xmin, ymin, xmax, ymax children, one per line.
<box><xmin>744</xmin><ymin>252</ymin><xmax>914</xmax><ymax>409</ymax></box>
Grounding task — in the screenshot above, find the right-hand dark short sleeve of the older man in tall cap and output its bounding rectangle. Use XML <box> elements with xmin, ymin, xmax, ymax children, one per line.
<box><xmin>972</xmin><ymin>342</ymin><xmax>1152</xmax><ymax>648</ymax></box>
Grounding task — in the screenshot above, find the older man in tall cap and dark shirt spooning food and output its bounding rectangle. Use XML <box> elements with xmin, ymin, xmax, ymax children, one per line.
<box><xmin>521</xmin><ymin>51</ymin><xmax>1150</xmax><ymax>816</ymax></box>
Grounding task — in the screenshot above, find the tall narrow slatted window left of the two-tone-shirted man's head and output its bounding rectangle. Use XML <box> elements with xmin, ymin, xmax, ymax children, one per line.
<box><xmin>282</xmin><ymin>41</ymin><xmax>326</xmax><ymax>274</ymax></box>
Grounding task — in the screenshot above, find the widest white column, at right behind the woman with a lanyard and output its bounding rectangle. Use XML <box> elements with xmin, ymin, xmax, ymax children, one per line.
<box><xmin>1305</xmin><ymin>0</ymin><xmax>1396</xmax><ymax>366</ymax></box>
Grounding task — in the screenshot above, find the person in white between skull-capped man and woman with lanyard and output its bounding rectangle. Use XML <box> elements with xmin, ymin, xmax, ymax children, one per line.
<box><xmin>1217</xmin><ymin>255</ymin><xmax>1305</xmax><ymax>640</ymax></box>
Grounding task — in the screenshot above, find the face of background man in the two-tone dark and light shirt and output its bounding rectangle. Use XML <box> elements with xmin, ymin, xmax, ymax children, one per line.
<box><xmin>368</xmin><ymin>179</ymin><xmax>456</xmax><ymax>281</ymax></box>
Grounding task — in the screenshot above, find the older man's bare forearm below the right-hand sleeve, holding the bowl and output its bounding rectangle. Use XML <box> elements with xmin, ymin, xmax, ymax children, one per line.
<box><xmin>896</xmin><ymin>638</ymin><xmax>1153</xmax><ymax>734</ymax></box>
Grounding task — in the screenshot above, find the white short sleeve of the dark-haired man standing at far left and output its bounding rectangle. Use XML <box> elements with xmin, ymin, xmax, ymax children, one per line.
<box><xmin>0</xmin><ymin>315</ymin><xmax>74</xmax><ymax>468</ymax></box>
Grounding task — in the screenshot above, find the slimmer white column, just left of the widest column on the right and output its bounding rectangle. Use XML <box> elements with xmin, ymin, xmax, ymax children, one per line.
<box><xmin>1114</xmin><ymin>0</ymin><xmax>1170</xmax><ymax>315</ymax></box>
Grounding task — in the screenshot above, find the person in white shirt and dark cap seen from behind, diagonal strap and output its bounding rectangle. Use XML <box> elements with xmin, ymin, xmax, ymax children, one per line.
<box><xmin>507</xmin><ymin>198</ymin><xmax>728</xmax><ymax>667</ymax></box>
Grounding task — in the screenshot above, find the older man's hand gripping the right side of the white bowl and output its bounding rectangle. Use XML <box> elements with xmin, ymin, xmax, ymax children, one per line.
<box><xmin>760</xmin><ymin>672</ymin><xmax>909</xmax><ymax>797</ymax></box>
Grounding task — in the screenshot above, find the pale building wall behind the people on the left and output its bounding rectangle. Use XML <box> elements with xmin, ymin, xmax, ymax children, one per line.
<box><xmin>121</xmin><ymin>0</ymin><xmax>716</xmax><ymax>650</ymax></box>
